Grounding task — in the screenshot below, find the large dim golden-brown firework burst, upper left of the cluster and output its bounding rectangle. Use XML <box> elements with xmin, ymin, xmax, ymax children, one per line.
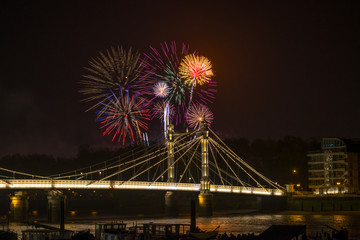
<box><xmin>80</xmin><ymin>47</ymin><xmax>146</xmax><ymax>111</ymax></box>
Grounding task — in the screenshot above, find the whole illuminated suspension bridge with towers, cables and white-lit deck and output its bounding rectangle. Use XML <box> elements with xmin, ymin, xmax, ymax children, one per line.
<box><xmin>0</xmin><ymin>124</ymin><xmax>285</xmax><ymax>220</ymax></box>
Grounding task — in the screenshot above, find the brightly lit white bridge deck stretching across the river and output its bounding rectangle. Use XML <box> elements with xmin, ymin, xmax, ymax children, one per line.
<box><xmin>0</xmin><ymin>179</ymin><xmax>284</xmax><ymax>196</ymax></box>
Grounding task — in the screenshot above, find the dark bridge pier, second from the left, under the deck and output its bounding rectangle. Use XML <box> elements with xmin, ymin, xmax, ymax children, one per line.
<box><xmin>47</xmin><ymin>190</ymin><xmax>65</xmax><ymax>223</ymax></box>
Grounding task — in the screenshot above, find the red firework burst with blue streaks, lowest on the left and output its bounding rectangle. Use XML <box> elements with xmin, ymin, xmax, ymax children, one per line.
<box><xmin>96</xmin><ymin>89</ymin><xmax>150</xmax><ymax>145</ymax></box>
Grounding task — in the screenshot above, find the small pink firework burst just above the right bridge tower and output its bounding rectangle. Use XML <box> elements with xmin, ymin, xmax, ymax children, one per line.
<box><xmin>186</xmin><ymin>104</ymin><xmax>214</xmax><ymax>129</ymax></box>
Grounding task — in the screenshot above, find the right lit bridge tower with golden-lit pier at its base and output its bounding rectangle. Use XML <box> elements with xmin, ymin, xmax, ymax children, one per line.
<box><xmin>198</xmin><ymin>122</ymin><xmax>213</xmax><ymax>217</ymax></box>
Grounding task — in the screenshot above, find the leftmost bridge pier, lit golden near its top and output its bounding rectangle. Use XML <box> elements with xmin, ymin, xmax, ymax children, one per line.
<box><xmin>10</xmin><ymin>191</ymin><xmax>29</xmax><ymax>222</ymax></box>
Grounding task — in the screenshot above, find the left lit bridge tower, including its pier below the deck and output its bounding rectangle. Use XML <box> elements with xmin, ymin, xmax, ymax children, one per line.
<box><xmin>165</xmin><ymin>124</ymin><xmax>178</xmax><ymax>217</ymax></box>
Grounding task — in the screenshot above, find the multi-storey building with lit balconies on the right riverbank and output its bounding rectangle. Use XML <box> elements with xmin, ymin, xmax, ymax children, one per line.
<box><xmin>307</xmin><ymin>138</ymin><xmax>360</xmax><ymax>194</ymax></box>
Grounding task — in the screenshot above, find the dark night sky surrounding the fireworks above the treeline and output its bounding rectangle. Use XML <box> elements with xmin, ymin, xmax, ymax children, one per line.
<box><xmin>0</xmin><ymin>0</ymin><xmax>360</xmax><ymax>156</ymax></box>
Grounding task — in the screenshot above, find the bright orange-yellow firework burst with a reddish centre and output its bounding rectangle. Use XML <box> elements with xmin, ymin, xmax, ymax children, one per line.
<box><xmin>179</xmin><ymin>54</ymin><xmax>214</xmax><ymax>86</ymax></box>
